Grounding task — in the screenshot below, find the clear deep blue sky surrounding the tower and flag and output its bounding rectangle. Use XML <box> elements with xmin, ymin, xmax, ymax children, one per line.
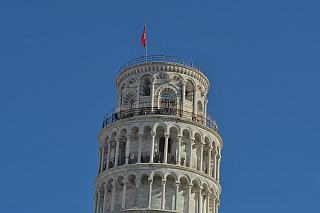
<box><xmin>0</xmin><ymin>0</ymin><xmax>320</xmax><ymax>213</ymax></box>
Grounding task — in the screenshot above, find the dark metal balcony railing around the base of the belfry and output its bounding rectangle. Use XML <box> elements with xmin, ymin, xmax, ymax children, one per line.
<box><xmin>102</xmin><ymin>107</ymin><xmax>218</xmax><ymax>132</ymax></box>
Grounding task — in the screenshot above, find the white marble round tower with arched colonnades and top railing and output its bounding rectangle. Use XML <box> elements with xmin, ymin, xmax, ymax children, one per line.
<box><xmin>94</xmin><ymin>55</ymin><xmax>223</xmax><ymax>213</ymax></box>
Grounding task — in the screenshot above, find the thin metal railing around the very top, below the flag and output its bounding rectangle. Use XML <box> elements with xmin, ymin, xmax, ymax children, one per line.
<box><xmin>119</xmin><ymin>55</ymin><xmax>206</xmax><ymax>75</ymax></box>
